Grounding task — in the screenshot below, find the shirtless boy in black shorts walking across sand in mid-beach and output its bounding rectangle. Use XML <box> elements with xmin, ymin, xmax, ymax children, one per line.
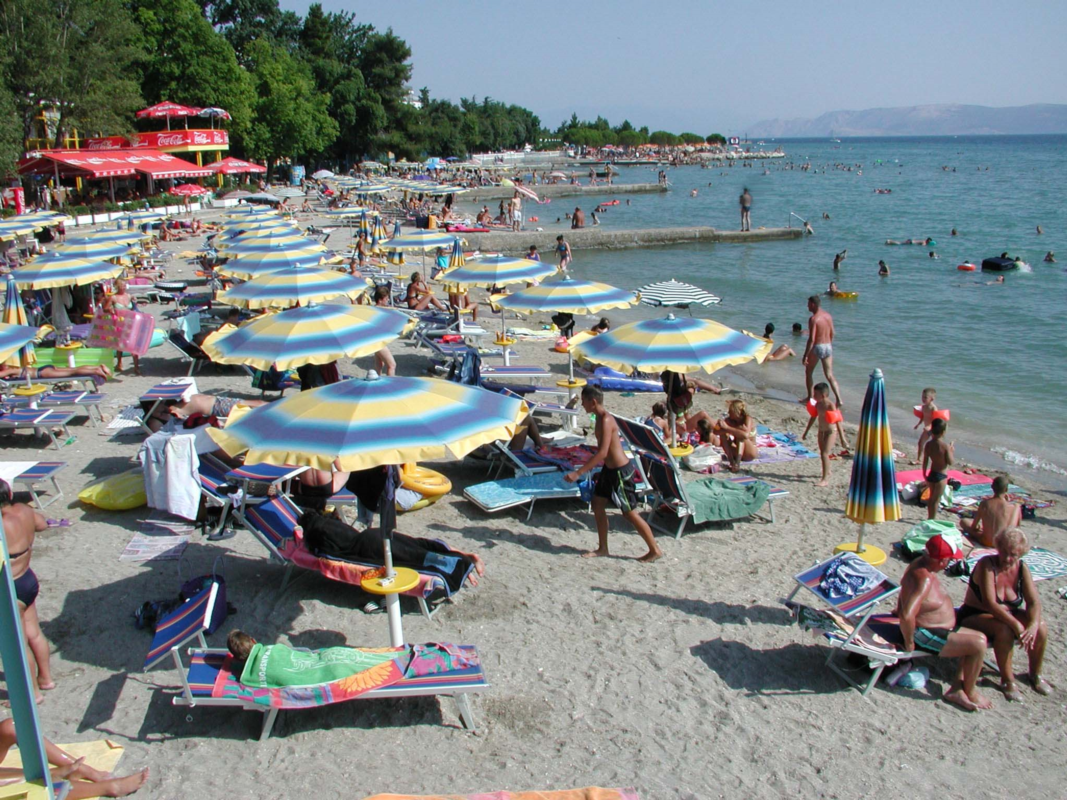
<box><xmin>564</xmin><ymin>386</ymin><xmax>664</xmax><ymax>563</ymax></box>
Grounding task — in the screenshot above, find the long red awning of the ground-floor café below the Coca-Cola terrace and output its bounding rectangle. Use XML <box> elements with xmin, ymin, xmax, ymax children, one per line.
<box><xmin>18</xmin><ymin>149</ymin><xmax>211</xmax><ymax>180</ymax></box>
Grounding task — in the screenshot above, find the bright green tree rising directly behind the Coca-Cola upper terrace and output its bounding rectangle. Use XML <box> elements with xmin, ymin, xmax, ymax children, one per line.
<box><xmin>130</xmin><ymin>0</ymin><xmax>255</xmax><ymax>142</ymax></box>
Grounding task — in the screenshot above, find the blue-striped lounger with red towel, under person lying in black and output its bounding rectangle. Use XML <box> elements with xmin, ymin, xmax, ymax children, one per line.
<box><xmin>235</xmin><ymin>495</ymin><xmax>451</xmax><ymax>619</ymax></box>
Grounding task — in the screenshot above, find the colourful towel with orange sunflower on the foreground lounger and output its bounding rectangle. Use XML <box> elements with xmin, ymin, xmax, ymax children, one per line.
<box><xmin>218</xmin><ymin>643</ymin><xmax>479</xmax><ymax>709</ymax></box>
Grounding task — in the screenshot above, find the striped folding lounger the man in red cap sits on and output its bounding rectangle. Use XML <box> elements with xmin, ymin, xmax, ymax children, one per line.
<box><xmin>784</xmin><ymin>553</ymin><xmax>917</xmax><ymax>698</ymax></box>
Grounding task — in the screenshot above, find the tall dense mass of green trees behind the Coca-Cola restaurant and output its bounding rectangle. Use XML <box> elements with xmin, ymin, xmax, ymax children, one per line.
<box><xmin>0</xmin><ymin>0</ymin><xmax>540</xmax><ymax>174</ymax></box>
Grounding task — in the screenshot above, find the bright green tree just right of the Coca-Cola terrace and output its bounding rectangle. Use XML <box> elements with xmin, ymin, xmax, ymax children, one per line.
<box><xmin>245</xmin><ymin>38</ymin><xmax>338</xmax><ymax>170</ymax></box>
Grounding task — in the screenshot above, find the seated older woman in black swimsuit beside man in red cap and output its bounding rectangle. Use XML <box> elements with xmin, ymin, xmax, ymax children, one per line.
<box><xmin>956</xmin><ymin>528</ymin><xmax>1051</xmax><ymax>701</ymax></box>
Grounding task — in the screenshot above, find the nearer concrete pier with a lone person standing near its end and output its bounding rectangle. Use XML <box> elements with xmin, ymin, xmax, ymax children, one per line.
<box><xmin>457</xmin><ymin>227</ymin><xmax>803</xmax><ymax>253</ymax></box>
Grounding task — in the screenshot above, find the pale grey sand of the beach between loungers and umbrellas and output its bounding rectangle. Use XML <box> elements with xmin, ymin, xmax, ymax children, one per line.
<box><xmin>0</xmin><ymin>218</ymin><xmax>1067</xmax><ymax>800</ymax></box>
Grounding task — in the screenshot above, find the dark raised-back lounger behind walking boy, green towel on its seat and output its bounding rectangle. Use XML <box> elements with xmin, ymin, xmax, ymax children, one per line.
<box><xmin>615</xmin><ymin>416</ymin><xmax>789</xmax><ymax>539</ymax></box>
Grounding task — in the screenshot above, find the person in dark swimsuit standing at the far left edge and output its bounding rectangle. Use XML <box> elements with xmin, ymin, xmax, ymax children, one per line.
<box><xmin>0</xmin><ymin>481</ymin><xmax>55</xmax><ymax>703</ymax></box>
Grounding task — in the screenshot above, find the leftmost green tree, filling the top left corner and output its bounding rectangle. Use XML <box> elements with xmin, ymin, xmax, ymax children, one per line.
<box><xmin>0</xmin><ymin>0</ymin><xmax>143</xmax><ymax>144</ymax></box>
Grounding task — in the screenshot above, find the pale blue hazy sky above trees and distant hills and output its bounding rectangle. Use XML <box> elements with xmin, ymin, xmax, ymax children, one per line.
<box><xmin>281</xmin><ymin>0</ymin><xmax>1067</xmax><ymax>135</ymax></box>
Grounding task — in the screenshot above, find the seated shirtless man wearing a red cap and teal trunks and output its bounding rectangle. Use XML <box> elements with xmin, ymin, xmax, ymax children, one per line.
<box><xmin>896</xmin><ymin>533</ymin><xmax>992</xmax><ymax>711</ymax></box>
